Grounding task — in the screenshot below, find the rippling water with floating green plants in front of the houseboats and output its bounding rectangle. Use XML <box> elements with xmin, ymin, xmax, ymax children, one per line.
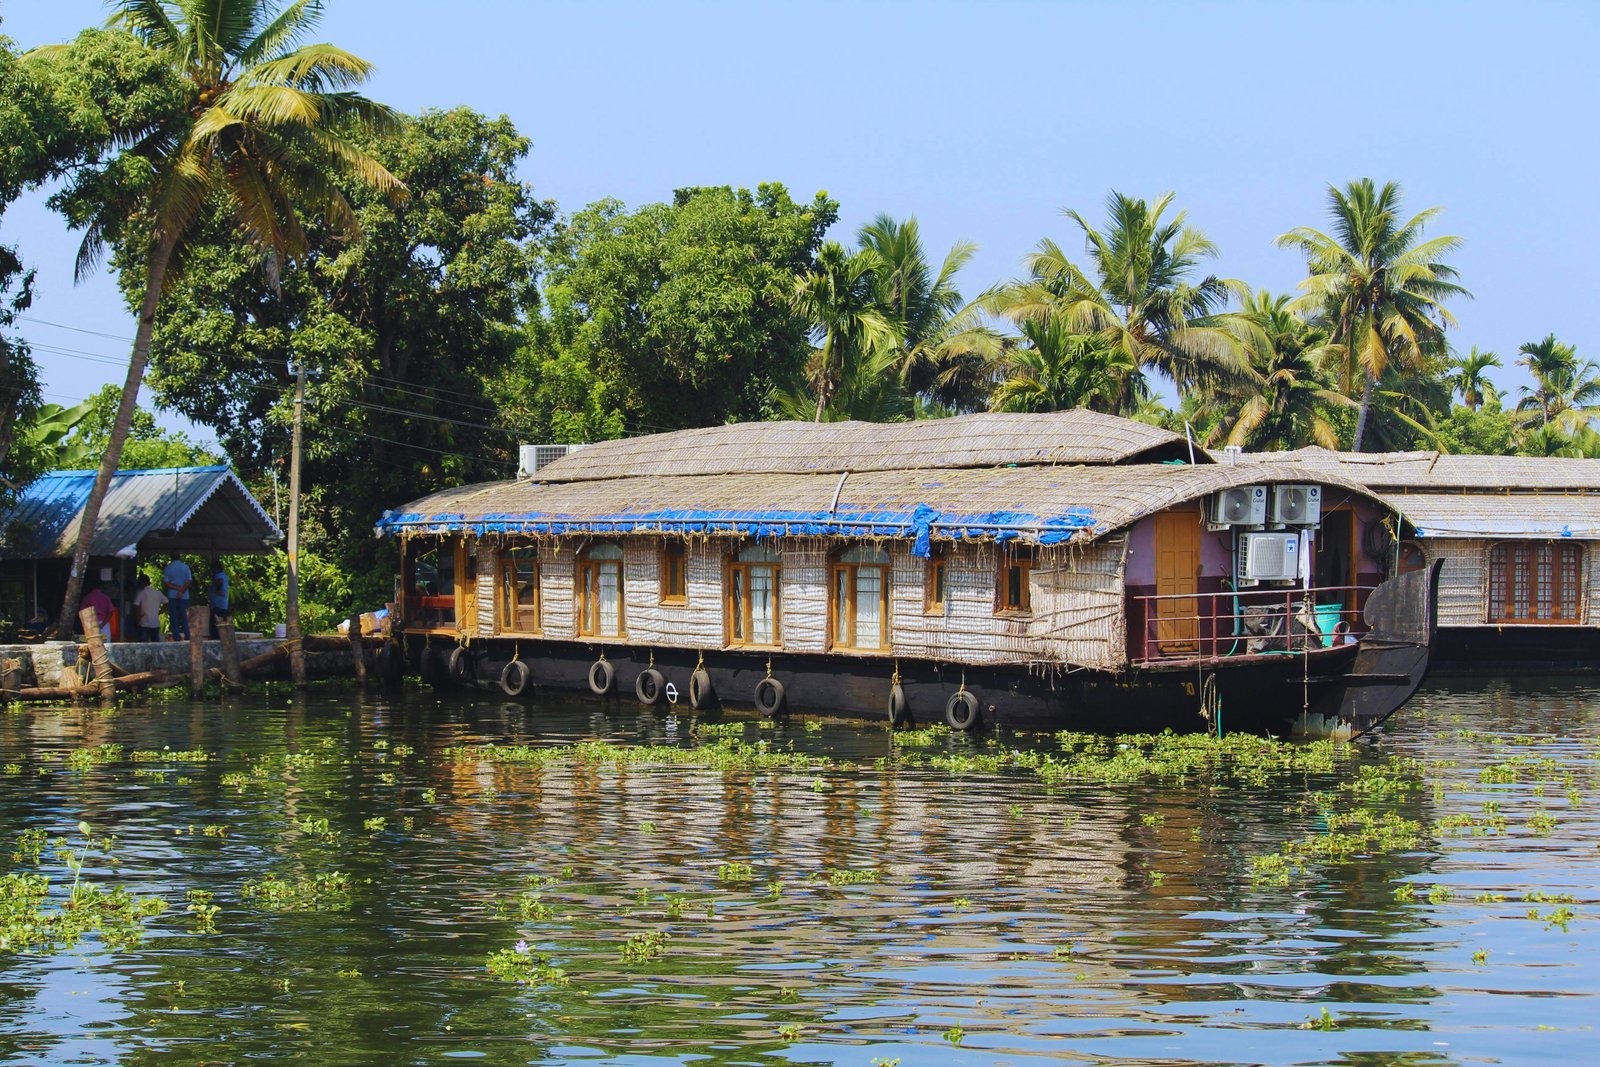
<box><xmin>0</xmin><ymin>680</ymin><xmax>1600</xmax><ymax>1067</ymax></box>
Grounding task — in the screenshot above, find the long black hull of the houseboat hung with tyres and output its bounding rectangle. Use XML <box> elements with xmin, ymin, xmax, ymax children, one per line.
<box><xmin>408</xmin><ymin>635</ymin><xmax>1358</xmax><ymax>734</ymax></box>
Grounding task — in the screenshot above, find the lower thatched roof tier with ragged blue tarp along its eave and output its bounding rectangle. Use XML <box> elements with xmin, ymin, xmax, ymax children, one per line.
<box><xmin>378</xmin><ymin>464</ymin><xmax>1368</xmax><ymax>544</ymax></box>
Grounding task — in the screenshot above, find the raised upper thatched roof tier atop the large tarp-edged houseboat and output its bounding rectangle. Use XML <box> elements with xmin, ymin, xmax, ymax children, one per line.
<box><xmin>538</xmin><ymin>411</ymin><xmax>1210</xmax><ymax>482</ymax></box>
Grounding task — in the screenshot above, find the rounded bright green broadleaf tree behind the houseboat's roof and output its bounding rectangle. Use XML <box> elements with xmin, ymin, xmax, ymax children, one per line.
<box><xmin>524</xmin><ymin>182</ymin><xmax>838</xmax><ymax>440</ymax></box>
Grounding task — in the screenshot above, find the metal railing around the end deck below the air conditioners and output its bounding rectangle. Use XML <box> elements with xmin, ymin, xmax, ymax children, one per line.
<box><xmin>1128</xmin><ymin>585</ymin><xmax>1373</xmax><ymax>662</ymax></box>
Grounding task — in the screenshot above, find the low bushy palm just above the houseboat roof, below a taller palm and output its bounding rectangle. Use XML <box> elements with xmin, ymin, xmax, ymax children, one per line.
<box><xmin>989</xmin><ymin>317</ymin><xmax>1150</xmax><ymax>416</ymax></box>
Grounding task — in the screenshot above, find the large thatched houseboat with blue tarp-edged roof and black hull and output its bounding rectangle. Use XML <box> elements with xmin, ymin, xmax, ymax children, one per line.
<box><xmin>378</xmin><ymin>411</ymin><xmax>1437</xmax><ymax>733</ymax></box>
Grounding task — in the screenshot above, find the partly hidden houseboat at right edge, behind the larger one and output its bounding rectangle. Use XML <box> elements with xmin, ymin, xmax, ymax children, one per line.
<box><xmin>1214</xmin><ymin>448</ymin><xmax>1600</xmax><ymax>672</ymax></box>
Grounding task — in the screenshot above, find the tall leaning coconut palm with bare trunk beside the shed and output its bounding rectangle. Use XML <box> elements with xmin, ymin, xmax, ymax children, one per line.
<box><xmin>32</xmin><ymin>0</ymin><xmax>403</xmax><ymax>633</ymax></box>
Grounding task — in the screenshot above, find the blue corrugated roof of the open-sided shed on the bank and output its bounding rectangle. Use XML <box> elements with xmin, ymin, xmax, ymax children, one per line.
<box><xmin>0</xmin><ymin>467</ymin><xmax>283</xmax><ymax>558</ymax></box>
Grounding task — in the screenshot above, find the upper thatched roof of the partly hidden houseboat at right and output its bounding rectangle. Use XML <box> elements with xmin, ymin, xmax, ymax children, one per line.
<box><xmin>1211</xmin><ymin>446</ymin><xmax>1600</xmax><ymax>493</ymax></box>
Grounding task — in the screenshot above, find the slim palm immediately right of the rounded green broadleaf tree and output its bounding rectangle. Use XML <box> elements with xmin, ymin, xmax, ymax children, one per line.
<box><xmin>790</xmin><ymin>242</ymin><xmax>898</xmax><ymax>422</ymax></box>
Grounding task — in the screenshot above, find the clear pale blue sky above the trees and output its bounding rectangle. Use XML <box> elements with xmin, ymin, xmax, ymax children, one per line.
<box><xmin>0</xmin><ymin>0</ymin><xmax>1600</xmax><ymax>441</ymax></box>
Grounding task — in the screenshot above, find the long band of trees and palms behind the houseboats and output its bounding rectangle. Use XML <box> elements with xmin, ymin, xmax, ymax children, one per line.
<box><xmin>0</xmin><ymin>0</ymin><xmax>1600</xmax><ymax>627</ymax></box>
